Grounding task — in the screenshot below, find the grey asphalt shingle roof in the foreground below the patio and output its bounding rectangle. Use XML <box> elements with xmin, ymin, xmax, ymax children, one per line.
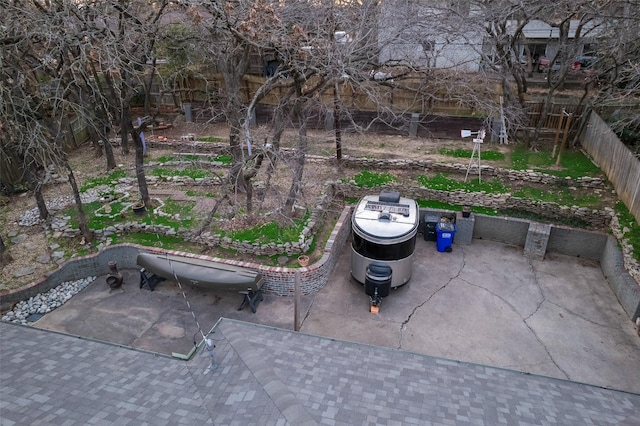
<box><xmin>0</xmin><ymin>319</ymin><xmax>640</xmax><ymax>426</ymax></box>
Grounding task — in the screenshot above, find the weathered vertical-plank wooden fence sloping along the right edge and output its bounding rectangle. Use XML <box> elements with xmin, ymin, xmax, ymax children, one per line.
<box><xmin>581</xmin><ymin>111</ymin><xmax>640</xmax><ymax>223</ymax></box>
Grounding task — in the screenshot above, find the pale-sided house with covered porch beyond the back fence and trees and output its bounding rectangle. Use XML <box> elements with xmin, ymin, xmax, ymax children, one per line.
<box><xmin>378</xmin><ymin>0</ymin><xmax>602</xmax><ymax>71</ymax></box>
